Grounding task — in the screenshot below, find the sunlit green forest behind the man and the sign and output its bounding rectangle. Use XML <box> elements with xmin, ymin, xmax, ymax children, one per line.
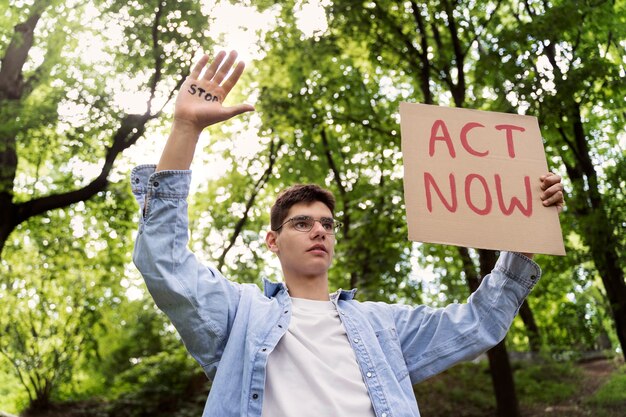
<box><xmin>0</xmin><ymin>0</ymin><xmax>626</xmax><ymax>417</ymax></box>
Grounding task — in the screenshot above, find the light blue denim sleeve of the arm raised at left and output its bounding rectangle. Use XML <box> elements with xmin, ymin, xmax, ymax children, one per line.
<box><xmin>131</xmin><ymin>165</ymin><xmax>241</xmax><ymax>369</ymax></box>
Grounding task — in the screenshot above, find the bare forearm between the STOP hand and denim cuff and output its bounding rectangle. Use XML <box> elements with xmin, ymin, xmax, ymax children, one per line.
<box><xmin>156</xmin><ymin>120</ymin><xmax>200</xmax><ymax>171</ymax></box>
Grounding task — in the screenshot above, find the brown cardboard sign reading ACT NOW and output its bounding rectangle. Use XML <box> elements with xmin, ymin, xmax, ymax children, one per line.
<box><xmin>400</xmin><ymin>103</ymin><xmax>565</xmax><ymax>255</ymax></box>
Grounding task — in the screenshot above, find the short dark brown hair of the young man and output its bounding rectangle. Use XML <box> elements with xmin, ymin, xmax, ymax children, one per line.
<box><xmin>270</xmin><ymin>184</ymin><xmax>335</xmax><ymax>230</ymax></box>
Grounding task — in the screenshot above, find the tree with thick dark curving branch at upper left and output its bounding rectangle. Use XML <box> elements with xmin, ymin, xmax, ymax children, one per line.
<box><xmin>0</xmin><ymin>0</ymin><xmax>212</xmax><ymax>254</ymax></box>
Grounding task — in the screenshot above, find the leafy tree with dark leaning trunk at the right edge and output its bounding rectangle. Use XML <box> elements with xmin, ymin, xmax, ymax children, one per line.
<box><xmin>484</xmin><ymin>1</ymin><xmax>626</xmax><ymax>357</ymax></box>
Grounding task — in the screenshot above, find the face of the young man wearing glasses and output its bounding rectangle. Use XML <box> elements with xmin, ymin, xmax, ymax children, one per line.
<box><xmin>266</xmin><ymin>201</ymin><xmax>335</xmax><ymax>278</ymax></box>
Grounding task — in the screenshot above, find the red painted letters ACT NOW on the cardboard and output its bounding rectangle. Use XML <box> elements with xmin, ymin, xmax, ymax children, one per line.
<box><xmin>424</xmin><ymin>119</ymin><xmax>533</xmax><ymax>217</ymax></box>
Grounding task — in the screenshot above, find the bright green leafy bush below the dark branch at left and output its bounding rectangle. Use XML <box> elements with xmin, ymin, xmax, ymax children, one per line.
<box><xmin>0</xmin><ymin>182</ymin><xmax>134</xmax><ymax>410</ymax></box>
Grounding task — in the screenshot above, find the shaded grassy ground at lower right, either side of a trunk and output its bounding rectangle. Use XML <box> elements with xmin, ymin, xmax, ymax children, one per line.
<box><xmin>414</xmin><ymin>362</ymin><xmax>626</xmax><ymax>417</ymax></box>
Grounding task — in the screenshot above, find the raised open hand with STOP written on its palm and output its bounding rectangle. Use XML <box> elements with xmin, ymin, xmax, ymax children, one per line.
<box><xmin>174</xmin><ymin>51</ymin><xmax>254</xmax><ymax>130</ymax></box>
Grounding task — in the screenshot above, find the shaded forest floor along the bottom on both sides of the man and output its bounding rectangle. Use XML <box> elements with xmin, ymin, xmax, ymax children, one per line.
<box><xmin>0</xmin><ymin>359</ymin><xmax>626</xmax><ymax>417</ymax></box>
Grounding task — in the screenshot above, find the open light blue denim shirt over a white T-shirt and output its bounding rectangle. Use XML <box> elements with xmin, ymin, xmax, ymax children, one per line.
<box><xmin>131</xmin><ymin>165</ymin><xmax>541</xmax><ymax>417</ymax></box>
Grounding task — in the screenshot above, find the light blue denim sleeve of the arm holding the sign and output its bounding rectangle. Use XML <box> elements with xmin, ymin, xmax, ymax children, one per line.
<box><xmin>392</xmin><ymin>252</ymin><xmax>541</xmax><ymax>383</ymax></box>
